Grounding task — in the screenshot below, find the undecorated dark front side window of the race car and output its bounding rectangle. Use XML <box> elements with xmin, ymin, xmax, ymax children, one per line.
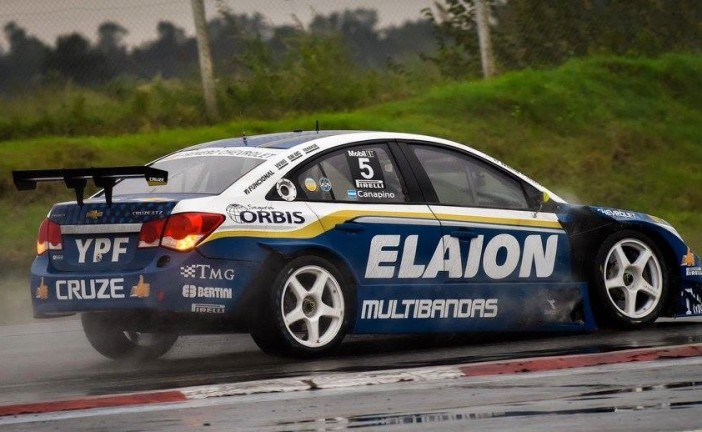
<box><xmin>412</xmin><ymin>145</ymin><xmax>529</xmax><ymax>209</ymax></box>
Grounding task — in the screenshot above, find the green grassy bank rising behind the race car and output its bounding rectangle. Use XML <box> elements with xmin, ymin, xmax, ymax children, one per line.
<box><xmin>0</xmin><ymin>55</ymin><xmax>702</xmax><ymax>280</ymax></box>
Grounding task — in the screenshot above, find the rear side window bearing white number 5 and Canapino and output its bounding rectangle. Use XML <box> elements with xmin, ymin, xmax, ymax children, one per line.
<box><xmin>293</xmin><ymin>144</ymin><xmax>405</xmax><ymax>203</ymax></box>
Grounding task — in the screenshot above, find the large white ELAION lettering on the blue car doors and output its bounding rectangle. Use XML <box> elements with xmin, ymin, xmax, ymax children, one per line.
<box><xmin>365</xmin><ymin>228</ymin><xmax>569</xmax><ymax>282</ymax></box>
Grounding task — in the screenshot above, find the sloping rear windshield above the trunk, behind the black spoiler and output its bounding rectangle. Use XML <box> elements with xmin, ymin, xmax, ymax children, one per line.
<box><xmin>113</xmin><ymin>149</ymin><xmax>275</xmax><ymax>196</ymax></box>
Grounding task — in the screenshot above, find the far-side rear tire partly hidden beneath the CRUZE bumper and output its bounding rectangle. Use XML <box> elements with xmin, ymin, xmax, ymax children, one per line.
<box><xmin>81</xmin><ymin>312</ymin><xmax>178</xmax><ymax>361</ymax></box>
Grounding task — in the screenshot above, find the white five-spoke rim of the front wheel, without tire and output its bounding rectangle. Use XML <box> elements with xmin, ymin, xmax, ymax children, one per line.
<box><xmin>604</xmin><ymin>238</ymin><xmax>663</xmax><ymax>319</ymax></box>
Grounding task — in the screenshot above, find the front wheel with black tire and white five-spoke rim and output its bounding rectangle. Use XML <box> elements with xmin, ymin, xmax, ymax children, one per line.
<box><xmin>592</xmin><ymin>230</ymin><xmax>670</xmax><ymax>329</ymax></box>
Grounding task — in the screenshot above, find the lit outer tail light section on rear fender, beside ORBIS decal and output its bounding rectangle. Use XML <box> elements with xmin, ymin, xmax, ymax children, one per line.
<box><xmin>160</xmin><ymin>213</ymin><xmax>224</xmax><ymax>252</ymax></box>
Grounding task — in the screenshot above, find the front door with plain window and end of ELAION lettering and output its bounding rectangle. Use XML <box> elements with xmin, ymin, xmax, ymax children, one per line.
<box><xmin>402</xmin><ymin>142</ymin><xmax>586</xmax><ymax>329</ymax></box>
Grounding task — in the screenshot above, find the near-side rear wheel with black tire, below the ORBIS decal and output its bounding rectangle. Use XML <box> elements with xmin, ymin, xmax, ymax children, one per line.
<box><xmin>250</xmin><ymin>256</ymin><xmax>354</xmax><ymax>358</ymax></box>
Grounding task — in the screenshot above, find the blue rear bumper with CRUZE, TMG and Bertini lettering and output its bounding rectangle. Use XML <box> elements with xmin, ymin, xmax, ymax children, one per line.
<box><xmin>30</xmin><ymin>252</ymin><xmax>260</xmax><ymax>318</ymax></box>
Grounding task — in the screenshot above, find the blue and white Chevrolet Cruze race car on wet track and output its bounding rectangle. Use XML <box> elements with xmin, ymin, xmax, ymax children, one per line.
<box><xmin>13</xmin><ymin>131</ymin><xmax>702</xmax><ymax>359</ymax></box>
